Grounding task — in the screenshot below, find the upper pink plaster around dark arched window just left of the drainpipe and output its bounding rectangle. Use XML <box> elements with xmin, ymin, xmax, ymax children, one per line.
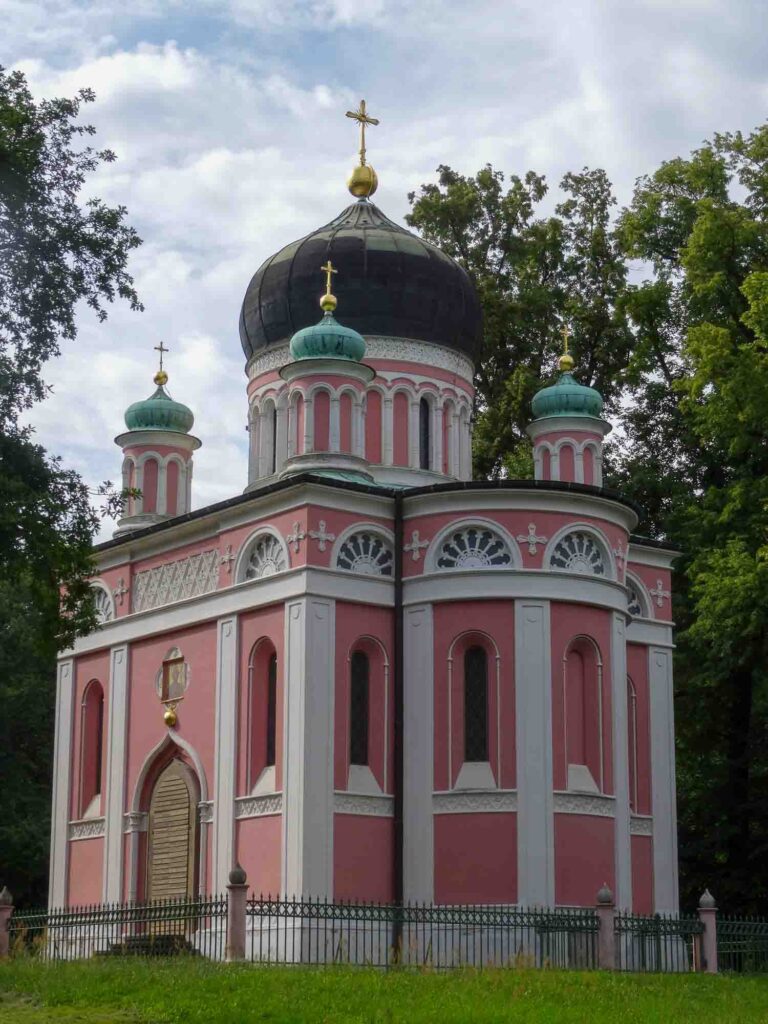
<box><xmin>334</xmin><ymin>601</ymin><xmax>394</xmax><ymax>793</ymax></box>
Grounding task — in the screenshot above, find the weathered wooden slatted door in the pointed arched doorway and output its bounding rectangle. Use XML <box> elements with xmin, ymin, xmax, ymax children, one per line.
<box><xmin>146</xmin><ymin>758</ymin><xmax>199</xmax><ymax>900</ymax></box>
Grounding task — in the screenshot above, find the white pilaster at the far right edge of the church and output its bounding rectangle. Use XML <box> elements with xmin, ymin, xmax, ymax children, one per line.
<box><xmin>648</xmin><ymin>647</ymin><xmax>679</xmax><ymax>913</ymax></box>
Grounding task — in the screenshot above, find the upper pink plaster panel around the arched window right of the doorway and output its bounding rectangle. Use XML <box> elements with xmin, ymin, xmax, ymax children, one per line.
<box><xmin>236</xmin><ymin>604</ymin><xmax>285</xmax><ymax>796</ymax></box>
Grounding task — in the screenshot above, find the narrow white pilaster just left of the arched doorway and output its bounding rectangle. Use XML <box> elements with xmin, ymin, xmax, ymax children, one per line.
<box><xmin>103</xmin><ymin>644</ymin><xmax>129</xmax><ymax>903</ymax></box>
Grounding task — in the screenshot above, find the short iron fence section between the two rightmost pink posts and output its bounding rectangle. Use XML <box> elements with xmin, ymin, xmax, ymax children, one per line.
<box><xmin>614</xmin><ymin>912</ymin><xmax>705</xmax><ymax>973</ymax></box>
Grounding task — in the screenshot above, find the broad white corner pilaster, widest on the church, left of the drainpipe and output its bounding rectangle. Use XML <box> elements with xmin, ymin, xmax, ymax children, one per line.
<box><xmin>281</xmin><ymin>597</ymin><xmax>336</xmax><ymax>897</ymax></box>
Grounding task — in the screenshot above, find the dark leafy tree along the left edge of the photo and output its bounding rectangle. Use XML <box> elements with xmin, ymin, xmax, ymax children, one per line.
<box><xmin>0</xmin><ymin>68</ymin><xmax>140</xmax><ymax>902</ymax></box>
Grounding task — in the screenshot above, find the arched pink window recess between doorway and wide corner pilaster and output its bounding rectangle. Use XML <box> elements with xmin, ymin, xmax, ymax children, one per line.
<box><xmin>248</xmin><ymin>639</ymin><xmax>278</xmax><ymax>791</ymax></box>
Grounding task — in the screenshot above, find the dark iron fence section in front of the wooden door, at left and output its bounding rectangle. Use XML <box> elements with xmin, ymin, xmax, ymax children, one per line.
<box><xmin>8</xmin><ymin>896</ymin><xmax>227</xmax><ymax>959</ymax></box>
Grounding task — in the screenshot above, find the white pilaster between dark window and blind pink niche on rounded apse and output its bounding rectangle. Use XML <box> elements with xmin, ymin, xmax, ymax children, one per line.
<box><xmin>515</xmin><ymin>600</ymin><xmax>555</xmax><ymax>906</ymax></box>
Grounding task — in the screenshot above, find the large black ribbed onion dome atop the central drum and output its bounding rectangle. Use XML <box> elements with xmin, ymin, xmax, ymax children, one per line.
<box><xmin>240</xmin><ymin>200</ymin><xmax>481</xmax><ymax>359</ymax></box>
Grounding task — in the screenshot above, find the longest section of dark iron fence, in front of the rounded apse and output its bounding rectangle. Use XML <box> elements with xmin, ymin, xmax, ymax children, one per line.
<box><xmin>246</xmin><ymin>896</ymin><xmax>598</xmax><ymax>969</ymax></box>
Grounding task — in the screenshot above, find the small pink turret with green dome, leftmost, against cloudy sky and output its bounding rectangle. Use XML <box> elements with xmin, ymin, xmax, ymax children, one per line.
<box><xmin>115</xmin><ymin>342</ymin><xmax>201</xmax><ymax>537</ymax></box>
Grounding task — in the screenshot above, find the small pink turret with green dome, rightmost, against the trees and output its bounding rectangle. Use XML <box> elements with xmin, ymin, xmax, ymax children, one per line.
<box><xmin>526</xmin><ymin>328</ymin><xmax>610</xmax><ymax>486</ymax></box>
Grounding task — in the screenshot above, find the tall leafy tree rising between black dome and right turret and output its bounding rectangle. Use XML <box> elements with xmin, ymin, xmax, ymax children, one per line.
<box><xmin>407</xmin><ymin>166</ymin><xmax>632</xmax><ymax>477</ymax></box>
